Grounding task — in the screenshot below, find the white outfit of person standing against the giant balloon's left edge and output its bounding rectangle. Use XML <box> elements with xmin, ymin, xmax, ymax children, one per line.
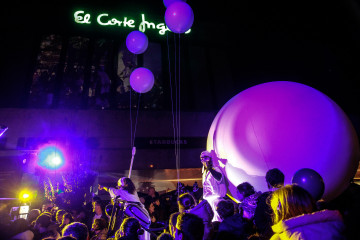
<box><xmin>202</xmin><ymin>167</ymin><xmax>227</xmax><ymax>222</ymax></box>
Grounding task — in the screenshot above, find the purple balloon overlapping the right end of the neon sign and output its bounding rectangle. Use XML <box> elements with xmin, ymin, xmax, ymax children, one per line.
<box><xmin>165</xmin><ymin>1</ymin><xmax>194</xmax><ymax>33</ymax></box>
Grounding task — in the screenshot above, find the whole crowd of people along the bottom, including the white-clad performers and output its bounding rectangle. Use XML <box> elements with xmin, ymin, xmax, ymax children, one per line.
<box><xmin>1</xmin><ymin>152</ymin><xmax>360</xmax><ymax>240</ymax></box>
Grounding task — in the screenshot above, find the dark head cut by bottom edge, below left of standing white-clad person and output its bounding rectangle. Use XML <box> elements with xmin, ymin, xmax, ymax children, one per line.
<box><xmin>175</xmin><ymin>213</ymin><xmax>204</xmax><ymax>240</ymax></box>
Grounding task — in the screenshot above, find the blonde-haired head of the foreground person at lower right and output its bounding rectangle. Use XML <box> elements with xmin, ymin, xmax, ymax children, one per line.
<box><xmin>270</xmin><ymin>184</ymin><xmax>316</xmax><ymax>224</ymax></box>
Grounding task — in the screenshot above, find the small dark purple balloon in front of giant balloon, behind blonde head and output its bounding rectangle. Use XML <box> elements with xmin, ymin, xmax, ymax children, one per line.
<box><xmin>291</xmin><ymin>168</ymin><xmax>325</xmax><ymax>201</ymax></box>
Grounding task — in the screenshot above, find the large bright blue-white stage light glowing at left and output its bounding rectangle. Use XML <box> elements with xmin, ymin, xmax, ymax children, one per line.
<box><xmin>38</xmin><ymin>146</ymin><xmax>65</xmax><ymax>170</ymax></box>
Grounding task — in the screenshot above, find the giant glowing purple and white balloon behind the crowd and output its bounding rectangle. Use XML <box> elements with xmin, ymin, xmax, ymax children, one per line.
<box><xmin>207</xmin><ymin>81</ymin><xmax>360</xmax><ymax>199</ymax></box>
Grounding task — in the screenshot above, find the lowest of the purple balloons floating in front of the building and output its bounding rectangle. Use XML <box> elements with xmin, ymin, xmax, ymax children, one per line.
<box><xmin>130</xmin><ymin>67</ymin><xmax>154</xmax><ymax>93</ymax></box>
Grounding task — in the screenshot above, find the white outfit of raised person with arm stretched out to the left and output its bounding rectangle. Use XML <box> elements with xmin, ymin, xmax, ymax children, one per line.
<box><xmin>109</xmin><ymin>188</ymin><xmax>151</xmax><ymax>240</ymax></box>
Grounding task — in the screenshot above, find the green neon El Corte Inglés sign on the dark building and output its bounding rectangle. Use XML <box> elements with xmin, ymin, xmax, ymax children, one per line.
<box><xmin>74</xmin><ymin>10</ymin><xmax>191</xmax><ymax>35</ymax></box>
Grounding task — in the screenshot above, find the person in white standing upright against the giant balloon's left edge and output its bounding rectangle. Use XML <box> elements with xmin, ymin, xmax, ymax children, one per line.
<box><xmin>200</xmin><ymin>151</ymin><xmax>227</xmax><ymax>222</ymax></box>
